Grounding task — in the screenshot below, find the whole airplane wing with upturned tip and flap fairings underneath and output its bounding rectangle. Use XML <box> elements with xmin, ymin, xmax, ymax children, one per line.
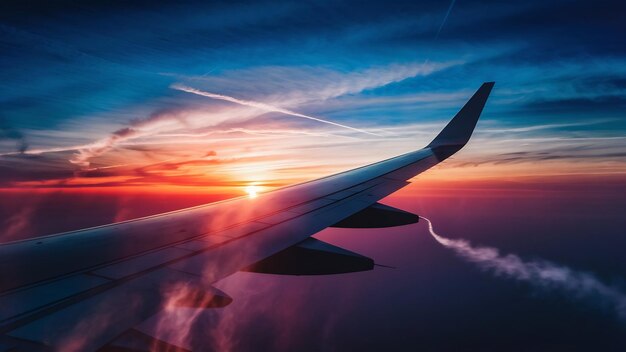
<box><xmin>0</xmin><ymin>82</ymin><xmax>494</xmax><ymax>351</ymax></box>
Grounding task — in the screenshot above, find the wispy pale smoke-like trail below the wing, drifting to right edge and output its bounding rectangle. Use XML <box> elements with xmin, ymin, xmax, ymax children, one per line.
<box><xmin>420</xmin><ymin>216</ymin><xmax>626</xmax><ymax>321</ymax></box>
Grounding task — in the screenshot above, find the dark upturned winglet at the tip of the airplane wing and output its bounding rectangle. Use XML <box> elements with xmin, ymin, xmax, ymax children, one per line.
<box><xmin>426</xmin><ymin>82</ymin><xmax>495</xmax><ymax>150</ymax></box>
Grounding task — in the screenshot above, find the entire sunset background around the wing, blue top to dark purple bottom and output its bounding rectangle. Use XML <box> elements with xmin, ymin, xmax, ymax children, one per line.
<box><xmin>0</xmin><ymin>0</ymin><xmax>626</xmax><ymax>351</ymax></box>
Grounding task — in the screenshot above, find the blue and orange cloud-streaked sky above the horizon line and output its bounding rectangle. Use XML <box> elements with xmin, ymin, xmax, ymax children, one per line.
<box><xmin>0</xmin><ymin>1</ymin><xmax>626</xmax><ymax>193</ymax></box>
